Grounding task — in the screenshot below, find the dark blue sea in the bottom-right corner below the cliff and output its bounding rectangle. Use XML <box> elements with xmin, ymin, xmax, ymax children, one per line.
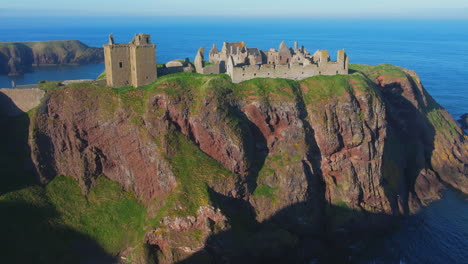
<box><xmin>360</xmin><ymin>190</ymin><xmax>468</xmax><ymax>264</ymax></box>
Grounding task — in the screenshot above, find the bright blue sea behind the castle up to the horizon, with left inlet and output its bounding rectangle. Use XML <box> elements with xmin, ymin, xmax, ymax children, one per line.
<box><xmin>0</xmin><ymin>18</ymin><xmax>468</xmax><ymax>118</ymax></box>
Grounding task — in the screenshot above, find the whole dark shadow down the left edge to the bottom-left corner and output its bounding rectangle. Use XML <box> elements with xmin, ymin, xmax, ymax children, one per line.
<box><xmin>0</xmin><ymin>104</ymin><xmax>115</xmax><ymax>264</ymax></box>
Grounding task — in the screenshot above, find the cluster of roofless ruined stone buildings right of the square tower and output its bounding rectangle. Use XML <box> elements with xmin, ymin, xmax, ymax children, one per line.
<box><xmin>194</xmin><ymin>42</ymin><xmax>349</xmax><ymax>83</ymax></box>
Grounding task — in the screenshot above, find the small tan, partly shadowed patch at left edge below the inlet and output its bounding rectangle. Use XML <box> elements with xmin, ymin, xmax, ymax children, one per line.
<box><xmin>0</xmin><ymin>88</ymin><xmax>45</xmax><ymax>116</ymax></box>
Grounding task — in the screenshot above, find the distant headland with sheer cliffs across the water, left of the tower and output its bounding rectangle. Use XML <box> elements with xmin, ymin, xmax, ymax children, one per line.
<box><xmin>0</xmin><ymin>40</ymin><xmax>104</xmax><ymax>75</ymax></box>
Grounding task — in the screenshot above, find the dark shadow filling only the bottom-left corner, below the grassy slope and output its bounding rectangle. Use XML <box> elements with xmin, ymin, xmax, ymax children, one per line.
<box><xmin>0</xmin><ymin>200</ymin><xmax>116</xmax><ymax>264</ymax></box>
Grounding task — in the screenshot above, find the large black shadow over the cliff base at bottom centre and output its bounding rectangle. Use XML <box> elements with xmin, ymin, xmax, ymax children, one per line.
<box><xmin>174</xmin><ymin>190</ymin><xmax>395</xmax><ymax>264</ymax></box>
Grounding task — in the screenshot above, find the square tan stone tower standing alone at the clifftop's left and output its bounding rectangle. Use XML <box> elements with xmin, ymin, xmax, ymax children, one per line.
<box><xmin>103</xmin><ymin>34</ymin><xmax>157</xmax><ymax>88</ymax></box>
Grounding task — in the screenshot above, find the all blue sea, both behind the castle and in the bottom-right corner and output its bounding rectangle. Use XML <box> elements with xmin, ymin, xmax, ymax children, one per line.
<box><xmin>0</xmin><ymin>17</ymin><xmax>468</xmax><ymax>263</ymax></box>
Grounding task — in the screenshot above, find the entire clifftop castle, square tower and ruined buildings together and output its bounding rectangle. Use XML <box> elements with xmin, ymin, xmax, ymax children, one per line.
<box><xmin>103</xmin><ymin>34</ymin><xmax>349</xmax><ymax>88</ymax></box>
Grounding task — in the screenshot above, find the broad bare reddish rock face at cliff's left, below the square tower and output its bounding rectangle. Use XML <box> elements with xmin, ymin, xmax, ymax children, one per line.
<box><xmin>31</xmin><ymin>86</ymin><xmax>176</xmax><ymax>200</ymax></box>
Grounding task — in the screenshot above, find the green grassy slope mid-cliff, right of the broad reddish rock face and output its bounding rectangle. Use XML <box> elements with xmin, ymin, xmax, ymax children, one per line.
<box><xmin>155</xmin><ymin>132</ymin><xmax>236</xmax><ymax>219</ymax></box>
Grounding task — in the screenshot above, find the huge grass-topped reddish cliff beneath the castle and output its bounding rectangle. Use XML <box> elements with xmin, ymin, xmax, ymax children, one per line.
<box><xmin>5</xmin><ymin>65</ymin><xmax>468</xmax><ymax>263</ymax></box>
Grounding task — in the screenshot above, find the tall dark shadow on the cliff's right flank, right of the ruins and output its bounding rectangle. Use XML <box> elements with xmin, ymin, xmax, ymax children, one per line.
<box><xmin>377</xmin><ymin>75</ymin><xmax>443</xmax><ymax>214</ymax></box>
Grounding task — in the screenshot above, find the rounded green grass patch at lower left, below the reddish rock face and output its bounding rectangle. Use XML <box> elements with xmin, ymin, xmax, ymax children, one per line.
<box><xmin>46</xmin><ymin>176</ymin><xmax>146</xmax><ymax>253</ymax></box>
